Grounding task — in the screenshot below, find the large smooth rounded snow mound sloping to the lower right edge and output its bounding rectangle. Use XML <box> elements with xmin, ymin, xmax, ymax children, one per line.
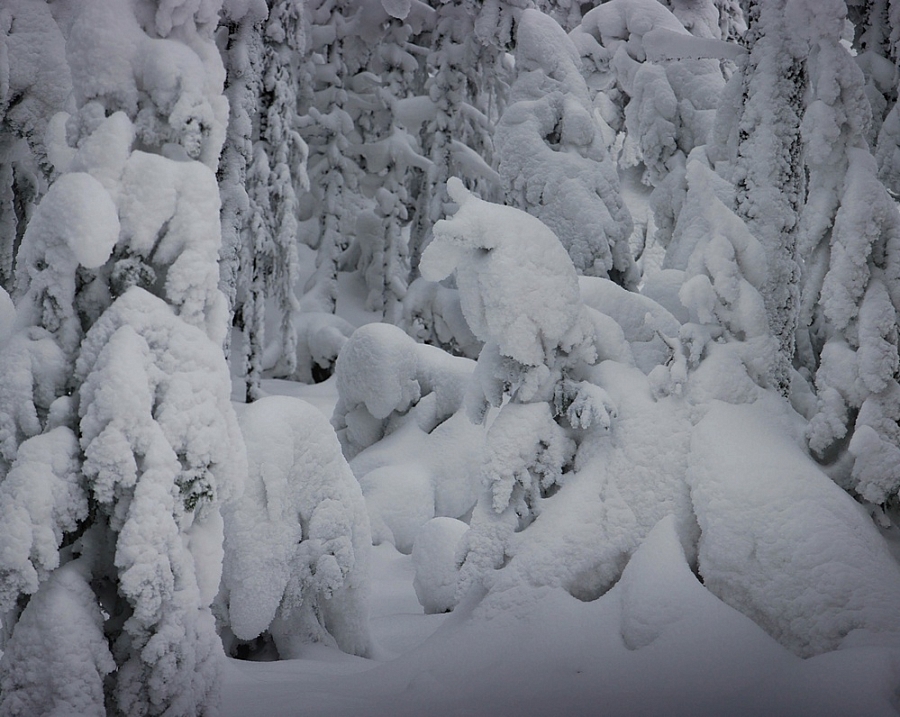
<box><xmin>688</xmin><ymin>399</ymin><xmax>900</xmax><ymax>656</ymax></box>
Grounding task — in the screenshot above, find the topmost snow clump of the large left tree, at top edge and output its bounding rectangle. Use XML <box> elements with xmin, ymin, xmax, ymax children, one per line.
<box><xmin>61</xmin><ymin>0</ymin><xmax>228</xmax><ymax>168</ymax></box>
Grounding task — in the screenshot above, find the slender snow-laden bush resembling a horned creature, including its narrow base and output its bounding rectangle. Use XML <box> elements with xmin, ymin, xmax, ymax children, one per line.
<box><xmin>421</xmin><ymin>179</ymin><xmax>615</xmax><ymax>608</ymax></box>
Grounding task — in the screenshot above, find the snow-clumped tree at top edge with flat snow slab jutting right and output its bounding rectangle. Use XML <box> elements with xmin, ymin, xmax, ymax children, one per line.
<box><xmin>570</xmin><ymin>0</ymin><xmax>742</xmax><ymax>255</ymax></box>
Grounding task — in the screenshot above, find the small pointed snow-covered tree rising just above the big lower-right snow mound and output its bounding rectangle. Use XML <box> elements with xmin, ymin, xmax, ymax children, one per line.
<box><xmin>651</xmin><ymin>152</ymin><xmax>777</xmax><ymax>403</ymax></box>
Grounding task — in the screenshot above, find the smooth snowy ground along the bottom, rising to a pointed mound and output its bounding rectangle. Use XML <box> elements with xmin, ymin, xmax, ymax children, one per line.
<box><xmin>222</xmin><ymin>381</ymin><xmax>900</xmax><ymax>717</ymax></box>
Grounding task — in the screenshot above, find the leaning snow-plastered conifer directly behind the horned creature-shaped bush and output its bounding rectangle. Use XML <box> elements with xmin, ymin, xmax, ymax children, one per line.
<box><xmin>495</xmin><ymin>10</ymin><xmax>636</xmax><ymax>284</ymax></box>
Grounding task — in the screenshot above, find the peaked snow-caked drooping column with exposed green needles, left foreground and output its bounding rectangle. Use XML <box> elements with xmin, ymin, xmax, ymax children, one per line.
<box><xmin>75</xmin><ymin>287</ymin><xmax>246</xmax><ymax>714</ymax></box>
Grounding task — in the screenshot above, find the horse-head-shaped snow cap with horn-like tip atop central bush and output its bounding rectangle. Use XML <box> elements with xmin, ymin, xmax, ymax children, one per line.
<box><xmin>421</xmin><ymin>177</ymin><xmax>581</xmax><ymax>366</ymax></box>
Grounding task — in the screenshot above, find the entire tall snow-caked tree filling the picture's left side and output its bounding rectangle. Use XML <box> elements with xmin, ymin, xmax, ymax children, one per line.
<box><xmin>0</xmin><ymin>0</ymin><xmax>244</xmax><ymax>715</ymax></box>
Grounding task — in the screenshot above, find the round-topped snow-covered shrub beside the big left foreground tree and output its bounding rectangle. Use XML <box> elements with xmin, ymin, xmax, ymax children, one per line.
<box><xmin>220</xmin><ymin>396</ymin><xmax>371</xmax><ymax>659</ymax></box>
